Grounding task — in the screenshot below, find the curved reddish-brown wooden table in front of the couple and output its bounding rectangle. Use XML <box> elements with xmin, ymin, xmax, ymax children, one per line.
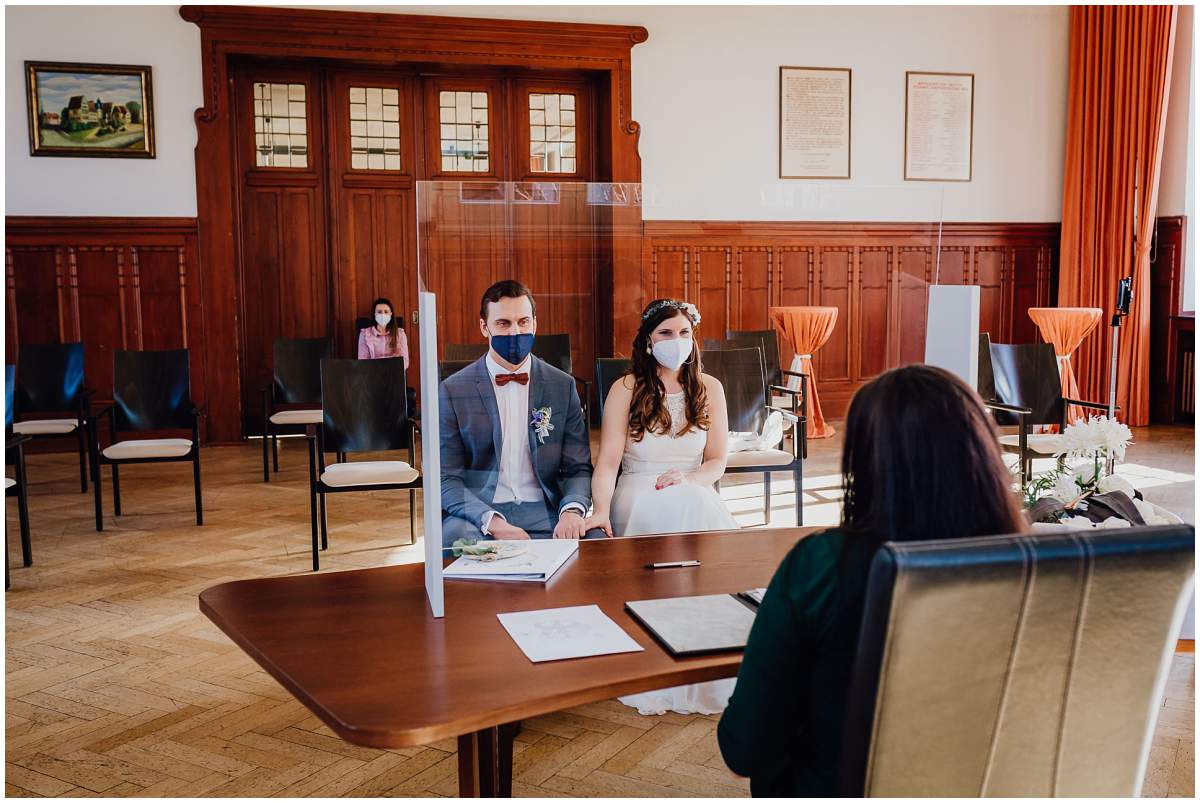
<box><xmin>200</xmin><ymin>528</ymin><xmax>814</xmax><ymax>797</ymax></box>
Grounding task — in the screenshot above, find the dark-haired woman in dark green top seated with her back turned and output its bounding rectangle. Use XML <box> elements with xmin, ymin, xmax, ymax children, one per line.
<box><xmin>718</xmin><ymin>365</ymin><xmax>1027</xmax><ymax>797</ymax></box>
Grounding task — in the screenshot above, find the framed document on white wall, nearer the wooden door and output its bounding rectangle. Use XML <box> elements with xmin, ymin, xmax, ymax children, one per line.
<box><xmin>779</xmin><ymin>67</ymin><xmax>850</xmax><ymax>179</ymax></box>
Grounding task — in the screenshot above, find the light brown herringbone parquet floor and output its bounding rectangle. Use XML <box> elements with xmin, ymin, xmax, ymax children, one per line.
<box><xmin>5</xmin><ymin>430</ymin><xmax>1195</xmax><ymax>797</ymax></box>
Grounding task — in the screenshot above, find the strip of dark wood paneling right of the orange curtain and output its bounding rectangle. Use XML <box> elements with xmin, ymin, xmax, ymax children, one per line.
<box><xmin>1150</xmin><ymin>216</ymin><xmax>1195</xmax><ymax>424</ymax></box>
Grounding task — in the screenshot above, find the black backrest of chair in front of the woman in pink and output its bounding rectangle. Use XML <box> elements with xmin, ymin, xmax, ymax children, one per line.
<box><xmin>320</xmin><ymin>356</ymin><xmax>409</xmax><ymax>451</ymax></box>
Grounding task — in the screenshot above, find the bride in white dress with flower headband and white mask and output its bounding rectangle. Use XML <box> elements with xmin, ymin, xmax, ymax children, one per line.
<box><xmin>586</xmin><ymin>299</ymin><xmax>738</xmax><ymax>714</ymax></box>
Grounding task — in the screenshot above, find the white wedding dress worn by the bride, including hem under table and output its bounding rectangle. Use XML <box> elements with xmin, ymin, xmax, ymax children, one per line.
<box><xmin>611</xmin><ymin>391</ymin><xmax>738</xmax><ymax>714</ymax></box>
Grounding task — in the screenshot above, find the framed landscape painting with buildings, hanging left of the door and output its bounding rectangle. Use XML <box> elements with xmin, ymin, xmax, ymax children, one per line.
<box><xmin>25</xmin><ymin>61</ymin><xmax>155</xmax><ymax>158</ymax></box>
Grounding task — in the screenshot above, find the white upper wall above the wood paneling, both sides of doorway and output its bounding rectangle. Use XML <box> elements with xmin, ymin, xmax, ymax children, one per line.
<box><xmin>5</xmin><ymin>6</ymin><xmax>1068</xmax><ymax>222</ymax></box>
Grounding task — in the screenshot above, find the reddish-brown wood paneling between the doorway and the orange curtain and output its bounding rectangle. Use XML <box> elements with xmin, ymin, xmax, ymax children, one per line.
<box><xmin>643</xmin><ymin>221</ymin><xmax>1058</xmax><ymax>417</ymax></box>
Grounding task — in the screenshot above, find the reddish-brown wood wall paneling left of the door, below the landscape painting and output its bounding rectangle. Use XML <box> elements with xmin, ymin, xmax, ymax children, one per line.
<box><xmin>5</xmin><ymin>216</ymin><xmax>208</xmax><ymax>434</ymax></box>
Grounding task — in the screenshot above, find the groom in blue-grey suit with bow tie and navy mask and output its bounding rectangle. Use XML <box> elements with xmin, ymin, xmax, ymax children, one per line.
<box><xmin>439</xmin><ymin>281</ymin><xmax>604</xmax><ymax>546</ymax></box>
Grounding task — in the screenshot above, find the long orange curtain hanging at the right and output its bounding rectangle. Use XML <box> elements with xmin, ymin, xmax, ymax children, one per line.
<box><xmin>1058</xmin><ymin>6</ymin><xmax>1176</xmax><ymax>426</ymax></box>
